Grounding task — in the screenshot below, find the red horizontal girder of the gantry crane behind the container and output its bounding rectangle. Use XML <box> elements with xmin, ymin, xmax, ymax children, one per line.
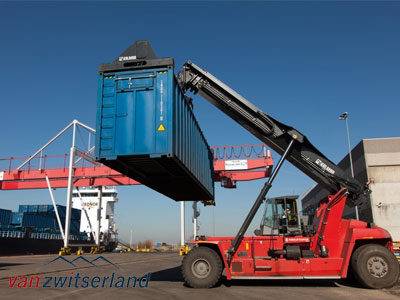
<box><xmin>0</xmin><ymin>144</ymin><xmax>273</xmax><ymax>190</ymax></box>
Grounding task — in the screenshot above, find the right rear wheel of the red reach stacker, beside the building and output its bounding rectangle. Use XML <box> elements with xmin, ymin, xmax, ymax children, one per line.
<box><xmin>351</xmin><ymin>244</ymin><xmax>400</xmax><ymax>289</ymax></box>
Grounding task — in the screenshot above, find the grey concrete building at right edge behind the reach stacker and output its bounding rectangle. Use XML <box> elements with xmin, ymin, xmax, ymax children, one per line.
<box><xmin>301</xmin><ymin>137</ymin><xmax>400</xmax><ymax>244</ymax></box>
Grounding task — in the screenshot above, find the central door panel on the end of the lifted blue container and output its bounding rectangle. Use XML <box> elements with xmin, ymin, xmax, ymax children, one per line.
<box><xmin>115</xmin><ymin>74</ymin><xmax>155</xmax><ymax>155</ymax></box>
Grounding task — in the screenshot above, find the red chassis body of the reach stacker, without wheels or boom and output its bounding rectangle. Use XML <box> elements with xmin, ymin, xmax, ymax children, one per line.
<box><xmin>190</xmin><ymin>190</ymin><xmax>392</xmax><ymax>280</ymax></box>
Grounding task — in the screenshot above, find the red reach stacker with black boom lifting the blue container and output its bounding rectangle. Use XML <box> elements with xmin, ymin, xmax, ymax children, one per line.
<box><xmin>178</xmin><ymin>62</ymin><xmax>399</xmax><ymax>288</ymax></box>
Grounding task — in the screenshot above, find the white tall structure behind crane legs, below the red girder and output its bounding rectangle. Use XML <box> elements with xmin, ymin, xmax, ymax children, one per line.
<box><xmin>72</xmin><ymin>186</ymin><xmax>118</xmax><ymax>244</ymax></box>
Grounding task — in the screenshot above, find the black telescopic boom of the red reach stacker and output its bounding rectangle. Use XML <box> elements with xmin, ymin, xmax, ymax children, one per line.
<box><xmin>178</xmin><ymin>62</ymin><xmax>364</xmax><ymax>205</ymax></box>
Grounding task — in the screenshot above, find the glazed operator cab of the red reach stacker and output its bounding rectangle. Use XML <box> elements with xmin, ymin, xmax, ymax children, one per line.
<box><xmin>254</xmin><ymin>195</ymin><xmax>301</xmax><ymax>236</ymax></box>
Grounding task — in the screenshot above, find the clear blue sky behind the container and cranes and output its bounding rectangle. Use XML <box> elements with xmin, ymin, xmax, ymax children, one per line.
<box><xmin>0</xmin><ymin>2</ymin><xmax>400</xmax><ymax>241</ymax></box>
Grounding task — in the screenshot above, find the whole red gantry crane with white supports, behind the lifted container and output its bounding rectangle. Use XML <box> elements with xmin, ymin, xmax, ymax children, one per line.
<box><xmin>0</xmin><ymin>120</ymin><xmax>273</xmax><ymax>254</ymax></box>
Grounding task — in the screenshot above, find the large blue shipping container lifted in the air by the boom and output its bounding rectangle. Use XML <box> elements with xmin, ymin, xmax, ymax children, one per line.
<box><xmin>96</xmin><ymin>44</ymin><xmax>214</xmax><ymax>201</ymax></box>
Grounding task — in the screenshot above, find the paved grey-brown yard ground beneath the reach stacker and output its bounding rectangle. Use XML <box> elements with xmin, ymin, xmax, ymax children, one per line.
<box><xmin>0</xmin><ymin>253</ymin><xmax>400</xmax><ymax>300</ymax></box>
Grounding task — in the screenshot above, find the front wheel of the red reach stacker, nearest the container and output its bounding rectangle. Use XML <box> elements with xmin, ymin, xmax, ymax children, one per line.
<box><xmin>182</xmin><ymin>247</ymin><xmax>222</xmax><ymax>288</ymax></box>
